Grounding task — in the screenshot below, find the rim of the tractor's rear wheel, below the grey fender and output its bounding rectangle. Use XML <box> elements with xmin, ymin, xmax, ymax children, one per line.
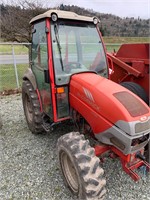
<box><xmin>25</xmin><ymin>95</ymin><xmax>33</xmax><ymax>123</ymax></box>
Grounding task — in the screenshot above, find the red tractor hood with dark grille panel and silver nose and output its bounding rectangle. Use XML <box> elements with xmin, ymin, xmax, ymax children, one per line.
<box><xmin>69</xmin><ymin>72</ymin><xmax>150</xmax><ymax>136</ymax></box>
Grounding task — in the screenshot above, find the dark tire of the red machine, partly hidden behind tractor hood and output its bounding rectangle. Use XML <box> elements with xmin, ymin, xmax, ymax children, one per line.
<box><xmin>120</xmin><ymin>82</ymin><xmax>149</xmax><ymax>104</ymax></box>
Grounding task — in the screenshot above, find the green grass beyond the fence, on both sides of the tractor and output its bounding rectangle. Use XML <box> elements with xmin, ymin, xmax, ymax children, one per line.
<box><xmin>0</xmin><ymin>37</ymin><xmax>150</xmax><ymax>91</ymax></box>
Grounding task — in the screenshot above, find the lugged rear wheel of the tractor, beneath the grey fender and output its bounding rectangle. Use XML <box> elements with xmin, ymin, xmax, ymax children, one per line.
<box><xmin>22</xmin><ymin>80</ymin><xmax>45</xmax><ymax>134</ymax></box>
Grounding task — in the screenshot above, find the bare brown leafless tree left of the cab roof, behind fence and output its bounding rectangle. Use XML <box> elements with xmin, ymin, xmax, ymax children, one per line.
<box><xmin>0</xmin><ymin>0</ymin><xmax>46</xmax><ymax>42</ymax></box>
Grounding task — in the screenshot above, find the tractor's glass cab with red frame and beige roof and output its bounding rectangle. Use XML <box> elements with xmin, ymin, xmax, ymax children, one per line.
<box><xmin>30</xmin><ymin>10</ymin><xmax>108</xmax><ymax>122</ymax></box>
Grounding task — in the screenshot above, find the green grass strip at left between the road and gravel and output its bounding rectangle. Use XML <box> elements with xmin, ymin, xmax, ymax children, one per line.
<box><xmin>0</xmin><ymin>64</ymin><xmax>28</xmax><ymax>91</ymax></box>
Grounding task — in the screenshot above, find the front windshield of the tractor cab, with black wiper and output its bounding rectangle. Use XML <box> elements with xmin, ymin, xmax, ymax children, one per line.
<box><xmin>51</xmin><ymin>22</ymin><xmax>108</xmax><ymax>85</ymax></box>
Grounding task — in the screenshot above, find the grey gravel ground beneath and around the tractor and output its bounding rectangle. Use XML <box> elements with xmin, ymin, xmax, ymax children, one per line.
<box><xmin>0</xmin><ymin>94</ymin><xmax>150</xmax><ymax>200</ymax></box>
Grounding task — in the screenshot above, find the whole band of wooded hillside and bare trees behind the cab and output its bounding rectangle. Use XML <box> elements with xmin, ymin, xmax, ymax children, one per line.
<box><xmin>0</xmin><ymin>0</ymin><xmax>149</xmax><ymax>42</ymax></box>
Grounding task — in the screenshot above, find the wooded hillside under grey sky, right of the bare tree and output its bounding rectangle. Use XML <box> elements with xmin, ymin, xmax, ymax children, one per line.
<box><xmin>60</xmin><ymin>5</ymin><xmax>149</xmax><ymax>37</ymax></box>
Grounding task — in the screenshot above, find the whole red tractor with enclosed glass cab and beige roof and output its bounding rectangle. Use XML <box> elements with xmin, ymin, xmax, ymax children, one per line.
<box><xmin>22</xmin><ymin>10</ymin><xmax>150</xmax><ymax>200</ymax></box>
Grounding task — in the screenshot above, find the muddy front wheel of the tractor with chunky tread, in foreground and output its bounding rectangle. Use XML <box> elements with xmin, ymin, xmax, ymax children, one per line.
<box><xmin>57</xmin><ymin>132</ymin><xmax>106</xmax><ymax>200</ymax></box>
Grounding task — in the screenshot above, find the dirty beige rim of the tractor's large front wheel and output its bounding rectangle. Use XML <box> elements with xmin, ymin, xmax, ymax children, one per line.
<box><xmin>60</xmin><ymin>151</ymin><xmax>79</xmax><ymax>193</ymax></box>
